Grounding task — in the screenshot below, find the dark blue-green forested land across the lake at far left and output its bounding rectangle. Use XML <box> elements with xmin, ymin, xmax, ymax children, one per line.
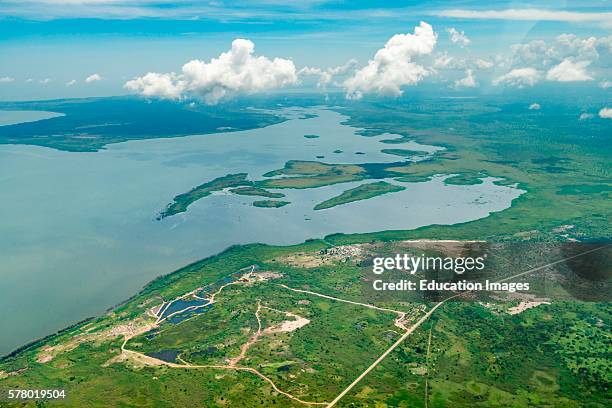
<box><xmin>0</xmin><ymin>97</ymin><xmax>284</xmax><ymax>152</ymax></box>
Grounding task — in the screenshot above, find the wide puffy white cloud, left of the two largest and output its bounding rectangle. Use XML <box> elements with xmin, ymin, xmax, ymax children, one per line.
<box><xmin>124</xmin><ymin>38</ymin><xmax>297</xmax><ymax>104</ymax></box>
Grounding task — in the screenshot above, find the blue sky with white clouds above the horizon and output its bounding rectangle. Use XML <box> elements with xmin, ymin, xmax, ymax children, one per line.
<box><xmin>0</xmin><ymin>0</ymin><xmax>612</xmax><ymax>102</ymax></box>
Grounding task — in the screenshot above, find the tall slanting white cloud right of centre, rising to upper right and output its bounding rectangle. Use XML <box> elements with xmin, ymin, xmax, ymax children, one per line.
<box><xmin>344</xmin><ymin>21</ymin><xmax>438</xmax><ymax>99</ymax></box>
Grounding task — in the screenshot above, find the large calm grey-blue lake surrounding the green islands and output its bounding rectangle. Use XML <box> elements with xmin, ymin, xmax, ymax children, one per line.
<box><xmin>0</xmin><ymin>108</ymin><xmax>523</xmax><ymax>354</ymax></box>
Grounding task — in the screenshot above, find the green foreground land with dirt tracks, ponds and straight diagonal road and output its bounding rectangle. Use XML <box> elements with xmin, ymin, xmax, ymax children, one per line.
<box><xmin>0</xmin><ymin>239</ymin><xmax>612</xmax><ymax>407</ymax></box>
